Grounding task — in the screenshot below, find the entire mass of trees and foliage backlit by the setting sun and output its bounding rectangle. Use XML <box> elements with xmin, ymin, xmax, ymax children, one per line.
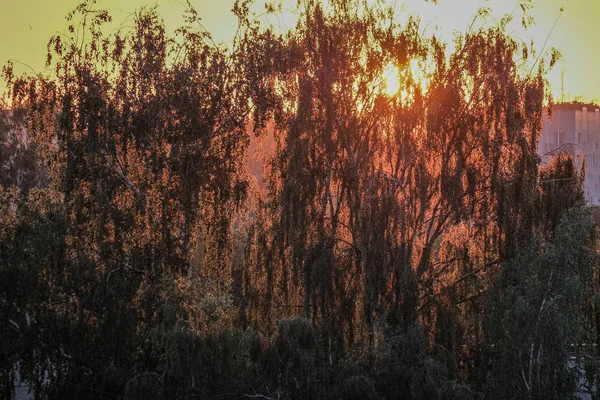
<box><xmin>0</xmin><ymin>0</ymin><xmax>600</xmax><ymax>400</ymax></box>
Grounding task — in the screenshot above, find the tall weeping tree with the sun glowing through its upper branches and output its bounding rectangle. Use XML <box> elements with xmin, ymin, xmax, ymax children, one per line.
<box><xmin>244</xmin><ymin>1</ymin><xmax>557</xmax><ymax>370</ymax></box>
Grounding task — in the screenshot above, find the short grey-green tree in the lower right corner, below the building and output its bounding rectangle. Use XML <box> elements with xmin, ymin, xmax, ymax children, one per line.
<box><xmin>486</xmin><ymin>207</ymin><xmax>598</xmax><ymax>399</ymax></box>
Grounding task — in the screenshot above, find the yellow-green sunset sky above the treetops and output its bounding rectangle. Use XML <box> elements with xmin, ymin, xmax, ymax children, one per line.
<box><xmin>0</xmin><ymin>0</ymin><xmax>600</xmax><ymax>101</ymax></box>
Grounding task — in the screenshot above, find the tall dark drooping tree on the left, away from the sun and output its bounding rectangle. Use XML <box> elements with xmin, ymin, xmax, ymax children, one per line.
<box><xmin>1</xmin><ymin>1</ymin><xmax>274</xmax><ymax>397</ymax></box>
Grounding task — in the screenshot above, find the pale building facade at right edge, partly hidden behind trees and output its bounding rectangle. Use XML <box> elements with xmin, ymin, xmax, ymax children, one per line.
<box><xmin>538</xmin><ymin>102</ymin><xmax>600</xmax><ymax>206</ymax></box>
